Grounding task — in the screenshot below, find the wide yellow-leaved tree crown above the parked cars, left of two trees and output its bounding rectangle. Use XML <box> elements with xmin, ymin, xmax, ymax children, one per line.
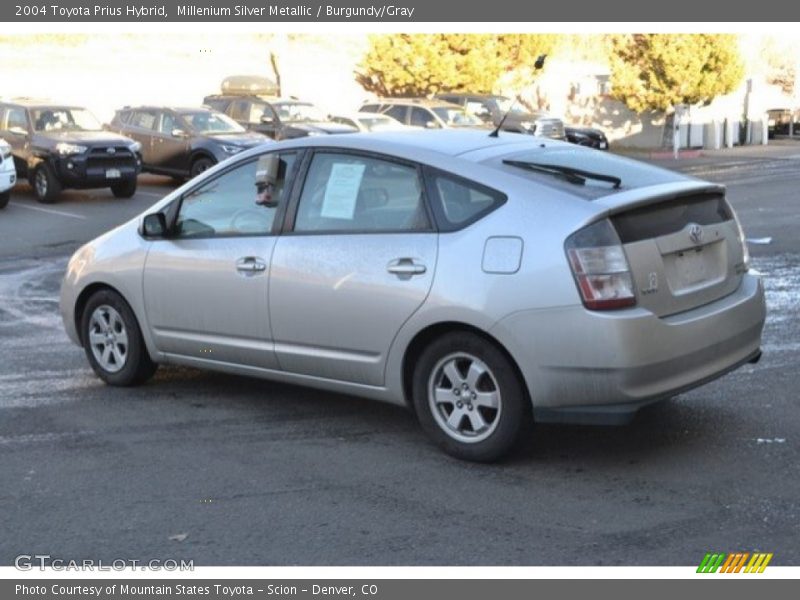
<box><xmin>356</xmin><ymin>34</ymin><xmax>556</xmax><ymax>96</ymax></box>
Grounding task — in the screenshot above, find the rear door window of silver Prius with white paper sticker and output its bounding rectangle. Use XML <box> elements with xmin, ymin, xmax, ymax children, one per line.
<box><xmin>294</xmin><ymin>152</ymin><xmax>430</xmax><ymax>233</ymax></box>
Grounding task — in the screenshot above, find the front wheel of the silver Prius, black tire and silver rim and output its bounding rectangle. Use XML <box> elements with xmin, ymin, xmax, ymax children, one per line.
<box><xmin>81</xmin><ymin>290</ymin><xmax>158</xmax><ymax>387</ymax></box>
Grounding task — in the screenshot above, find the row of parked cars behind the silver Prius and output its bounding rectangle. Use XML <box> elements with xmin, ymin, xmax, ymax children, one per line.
<box><xmin>0</xmin><ymin>76</ymin><xmax>608</xmax><ymax>207</ymax></box>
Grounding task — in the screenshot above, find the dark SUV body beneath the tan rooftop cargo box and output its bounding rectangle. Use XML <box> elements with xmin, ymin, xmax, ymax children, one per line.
<box><xmin>203</xmin><ymin>94</ymin><xmax>358</xmax><ymax>140</ymax></box>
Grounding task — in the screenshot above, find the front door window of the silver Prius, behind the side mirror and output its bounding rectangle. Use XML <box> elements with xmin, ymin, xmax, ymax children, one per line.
<box><xmin>175</xmin><ymin>152</ymin><xmax>295</xmax><ymax>238</ymax></box>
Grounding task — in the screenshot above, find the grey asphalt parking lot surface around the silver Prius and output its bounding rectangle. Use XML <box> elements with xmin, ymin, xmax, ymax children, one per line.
<box><xmin>0</xmin><ymin>144</ymin><xmax>800</xmax><ymax>565</ymax></box>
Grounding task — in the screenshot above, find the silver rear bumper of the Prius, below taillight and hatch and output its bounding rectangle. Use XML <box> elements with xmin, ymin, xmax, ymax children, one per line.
<box><xmin>495</xmin><ymin>275</ymin><xmax>766</xmax><ymax>422</ymax></box>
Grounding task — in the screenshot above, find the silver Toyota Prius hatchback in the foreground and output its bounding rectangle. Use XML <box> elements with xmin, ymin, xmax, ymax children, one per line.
<box><xmin>61</xmin><ymin>130</ymin><xmax>765</xmax><ymax>461</ymax></box>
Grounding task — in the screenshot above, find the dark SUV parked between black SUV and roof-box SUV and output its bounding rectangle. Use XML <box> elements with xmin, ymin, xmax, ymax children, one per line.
<box><xmin>108</xmin><ymin>106</ymin><xmax>272</xmax><ymax>178</ymax></box>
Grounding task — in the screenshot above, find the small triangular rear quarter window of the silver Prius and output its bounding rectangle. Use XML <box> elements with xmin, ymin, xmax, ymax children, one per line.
<box><xmin>433</xmin><ymin>172</ymin><xmax>506</xmax><ymax>230</ymax></box>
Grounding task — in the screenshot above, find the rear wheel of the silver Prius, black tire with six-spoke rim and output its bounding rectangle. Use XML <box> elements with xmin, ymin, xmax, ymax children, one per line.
<box><xmin>412</xmin><ymin>332</ymin><xmax>533</xmax><ymax>462</ymax></box>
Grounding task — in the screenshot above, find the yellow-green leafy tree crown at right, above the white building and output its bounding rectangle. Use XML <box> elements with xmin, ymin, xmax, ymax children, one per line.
<box><xmin>610</xmin><ymin>34</ymin><xmax>744</xmax><ymax>112</ymax></box>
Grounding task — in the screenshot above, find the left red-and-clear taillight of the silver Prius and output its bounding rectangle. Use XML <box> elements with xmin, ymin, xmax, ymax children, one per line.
<box><xmin>564</xmin><ymin>220</ymin><xmax>636</xmax><ymax>310</ymax></box>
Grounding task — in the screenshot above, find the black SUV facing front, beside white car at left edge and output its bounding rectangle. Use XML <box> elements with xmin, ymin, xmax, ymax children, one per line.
<box><xmin>0</xmin><ymin>100</ymin><xmax>141</xmax><ymax>202</ymax></box>
